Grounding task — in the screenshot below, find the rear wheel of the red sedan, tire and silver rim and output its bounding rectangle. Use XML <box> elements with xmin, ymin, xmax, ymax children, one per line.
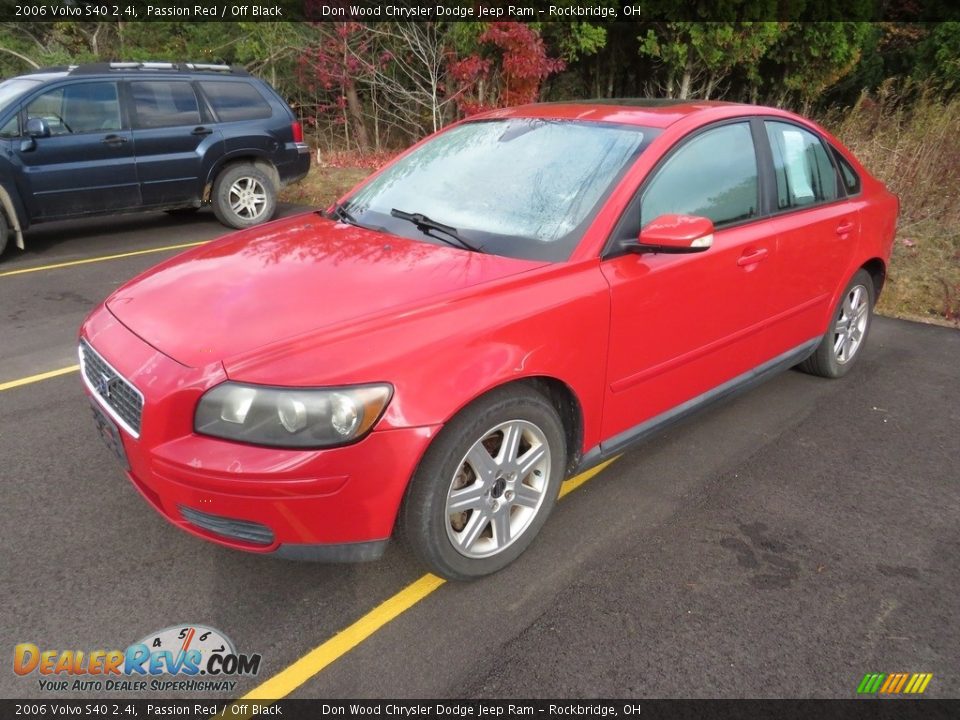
<box><xmin>798</xmin><ymin>270</ymin><xmax>876</xmax><ymax>378</ymax></box>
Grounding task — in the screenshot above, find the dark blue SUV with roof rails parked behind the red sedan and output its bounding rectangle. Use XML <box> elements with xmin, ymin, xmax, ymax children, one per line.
<box><xmin>0</xmin><ymin>63</ymin><xmax>310</xmax><ymax>253</ymax></box>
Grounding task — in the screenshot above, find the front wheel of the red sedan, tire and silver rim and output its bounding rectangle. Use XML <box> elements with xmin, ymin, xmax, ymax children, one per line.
<box><xmin>398</xmin><ymin>385</ymin><xmax>567</xmax><ymax>580</ymax></box>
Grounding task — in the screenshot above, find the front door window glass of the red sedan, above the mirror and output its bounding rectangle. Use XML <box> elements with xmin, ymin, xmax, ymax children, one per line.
<box><xmin>640</xmin><ymin>123</ymin><xmax>759</xmax><ymax>226</ymax></box>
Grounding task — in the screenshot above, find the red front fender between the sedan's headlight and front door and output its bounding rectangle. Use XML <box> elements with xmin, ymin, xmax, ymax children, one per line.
<box><xmin>224</xmin><ymin>260</ymin><xmax>610</xmax><ymax>456</ymax></box>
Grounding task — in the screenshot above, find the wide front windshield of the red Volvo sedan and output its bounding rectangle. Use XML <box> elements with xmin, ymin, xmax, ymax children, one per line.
<box><xmin>344</xmin><ymin>118</ymin><xmax>653</xmax><ymax>260</ymax></box>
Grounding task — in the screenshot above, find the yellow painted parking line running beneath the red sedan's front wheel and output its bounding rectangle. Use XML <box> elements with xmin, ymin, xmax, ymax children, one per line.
<box><xmin>232</xmin><ymin>455</ymin><xmax>621</xmax><ymax>704</ymax></box>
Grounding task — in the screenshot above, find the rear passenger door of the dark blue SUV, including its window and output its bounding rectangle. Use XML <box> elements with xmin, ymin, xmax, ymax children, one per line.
<box><xmin>127</xmin><ymin>78</ymin><xmax>223</xmax><ymax>206</ymax></box>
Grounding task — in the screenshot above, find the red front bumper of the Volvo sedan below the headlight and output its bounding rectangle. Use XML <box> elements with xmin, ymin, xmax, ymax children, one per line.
<box><xmin>81</xmin><ymin>307</ymin><xmax>437</xmax><ymax>561</ymax></box>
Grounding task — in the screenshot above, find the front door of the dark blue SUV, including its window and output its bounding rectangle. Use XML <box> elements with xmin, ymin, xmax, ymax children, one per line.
<box><xmin>12</xmin><ymin>80</ymin><xmax>140</xmax><ymax>219</ymax></box>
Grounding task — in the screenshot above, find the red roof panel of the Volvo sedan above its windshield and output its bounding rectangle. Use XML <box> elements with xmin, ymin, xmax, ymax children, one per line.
<box><xmin>474</xmin><ymin>98</ymin><xmax>790</xmax><ymax>128</ymax></box>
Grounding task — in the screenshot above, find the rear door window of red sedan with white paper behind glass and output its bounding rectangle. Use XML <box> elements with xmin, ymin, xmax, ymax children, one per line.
<box><xmin>764</xmin><ymin>121</ymin><xmax>838</xmax><ymax>210</ymax></box>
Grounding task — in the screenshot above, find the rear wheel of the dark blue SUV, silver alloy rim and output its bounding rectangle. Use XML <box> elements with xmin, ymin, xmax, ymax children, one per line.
<box><xmin>212</xmin><ymin>163</ymin><xmax>277</xmax><ymax>230</ymax></box>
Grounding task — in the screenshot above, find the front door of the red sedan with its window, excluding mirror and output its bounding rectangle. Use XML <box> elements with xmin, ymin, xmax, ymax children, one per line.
<box><xmin>601</xmin><ymin>120</ymin><xmax>776</xmax><ymax>446</ymax></box>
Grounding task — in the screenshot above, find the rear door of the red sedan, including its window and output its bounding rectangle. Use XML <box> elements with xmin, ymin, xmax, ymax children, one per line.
<box><xmin>763</xmin><ymin>119</ymin><xmax>860</xmax><ymax>350</ymax></box>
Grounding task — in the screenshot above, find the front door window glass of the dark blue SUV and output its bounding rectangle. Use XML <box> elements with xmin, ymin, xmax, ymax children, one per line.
<box><xmin>27</xmin><ymin>82</ymin><xmax>120</xmax><ymax>135</ymax></box>
